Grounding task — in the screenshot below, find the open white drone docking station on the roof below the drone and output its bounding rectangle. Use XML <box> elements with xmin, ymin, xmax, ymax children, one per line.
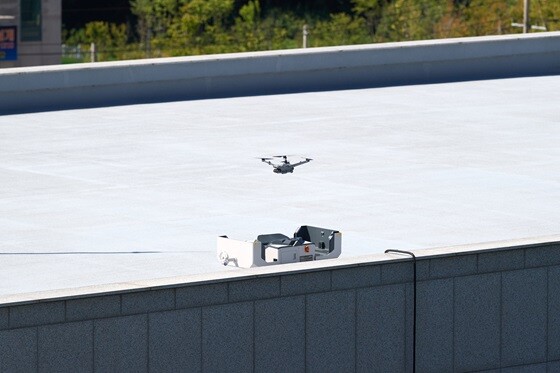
<box><xmin>218</xmin><ymin>225</ymin><xmax>342</xmax><ymax>268</ymax></box>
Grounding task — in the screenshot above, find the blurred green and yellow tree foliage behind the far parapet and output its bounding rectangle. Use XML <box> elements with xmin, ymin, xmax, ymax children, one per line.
<box><xmin>65</xmin><ymin>0</ymin><xmax>560</xmax><ymax>59</ymax></box>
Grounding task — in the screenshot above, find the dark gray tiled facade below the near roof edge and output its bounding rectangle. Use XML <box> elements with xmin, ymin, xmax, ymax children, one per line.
<box><xmin>0</xmin><ymin>244</ymin><xmax>560</xmax><ymax>372</ymax></box>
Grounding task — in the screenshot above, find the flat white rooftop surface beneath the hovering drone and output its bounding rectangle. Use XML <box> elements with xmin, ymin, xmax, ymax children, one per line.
<box><xmin>0</xmin><ymin>76</ymin><xmax>560</xmax><ymax>296</ymax></box>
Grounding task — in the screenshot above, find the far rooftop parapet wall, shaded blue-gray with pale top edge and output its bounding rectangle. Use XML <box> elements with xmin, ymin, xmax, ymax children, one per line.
<box><xmin>0</xmin><ymin>32</ymin><xmax>560</xmax><ymax>113</ymax></box>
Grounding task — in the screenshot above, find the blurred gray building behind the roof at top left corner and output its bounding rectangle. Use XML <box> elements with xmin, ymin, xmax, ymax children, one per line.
<box><xmin>0</xmin><ymin>0</ymin><xmax>62</xmax><ymax>68</ymax></box>
